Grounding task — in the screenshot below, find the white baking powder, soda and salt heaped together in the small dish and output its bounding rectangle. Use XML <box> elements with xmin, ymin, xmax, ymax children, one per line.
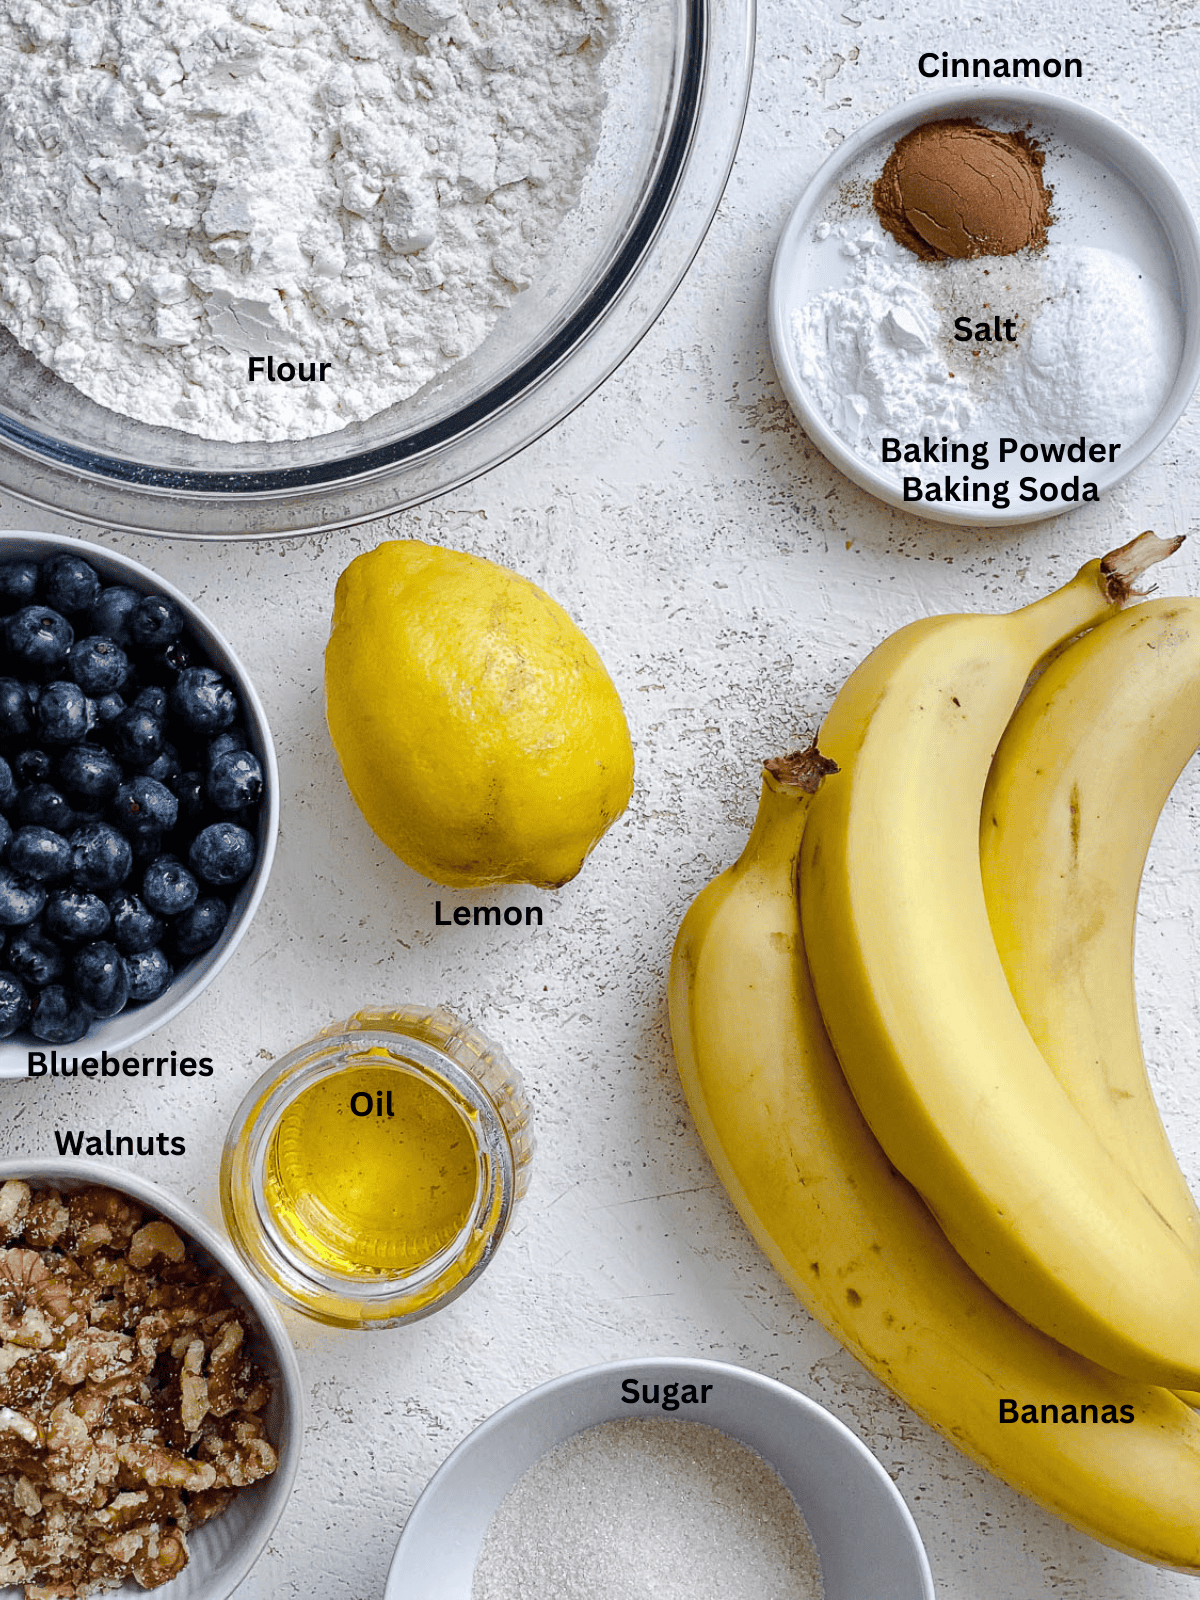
<box><xmin>792</xmin><ymin>226</ymin><xmax>1182</xmax><ymax>475</ymax></box>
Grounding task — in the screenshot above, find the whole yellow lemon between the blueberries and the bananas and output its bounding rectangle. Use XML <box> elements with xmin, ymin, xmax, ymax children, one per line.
<box><xmin>325</xmin><ymin>539</ymin><xmax>634</xmax><ymax>888</ymax></box>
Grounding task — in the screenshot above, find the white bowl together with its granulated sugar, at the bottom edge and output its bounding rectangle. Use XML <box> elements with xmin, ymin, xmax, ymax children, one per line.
<box><xmin>384</xmin><ymin>1357</ymin><xmax>933</xmax><ymax>1600</ymax></box>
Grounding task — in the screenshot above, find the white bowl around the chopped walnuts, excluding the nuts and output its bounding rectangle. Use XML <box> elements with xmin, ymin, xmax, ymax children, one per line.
<box><xmin>0</xmin><ymin>1160</ymin><xmax>304</xmax><ymax>1600</ymax></box>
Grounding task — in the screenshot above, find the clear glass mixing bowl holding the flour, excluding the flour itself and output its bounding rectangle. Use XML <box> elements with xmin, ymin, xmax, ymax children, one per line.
<box><xmin>0</xmin><ymin>0</ymin><xmax>755</xmax><ymax>539</ymax></box>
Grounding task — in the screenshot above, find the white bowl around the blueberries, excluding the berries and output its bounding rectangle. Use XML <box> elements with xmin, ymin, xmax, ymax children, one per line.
<box><xmin>0</xmin><ymin>530</ymin><xmax>278</xmax><ymax>1078</ymax></box>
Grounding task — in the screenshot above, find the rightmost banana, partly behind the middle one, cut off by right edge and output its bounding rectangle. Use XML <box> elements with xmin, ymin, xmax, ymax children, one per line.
<box><xmin>979</xmin><ymin>600</ymin><xmax>1200</xmax><ymax>1256</ymax></box>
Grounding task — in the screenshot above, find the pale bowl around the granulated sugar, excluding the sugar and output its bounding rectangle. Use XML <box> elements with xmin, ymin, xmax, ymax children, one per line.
<box><xmin>384</xmin><ymin>1357</ymin><xmax>933</xmax><ymax>1600</ymax></box>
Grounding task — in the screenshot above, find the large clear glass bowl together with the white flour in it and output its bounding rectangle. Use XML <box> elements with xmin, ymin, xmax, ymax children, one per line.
<box><xmin>0</xmin><ymin>0</ymin><xmax>754</xmax><ymax>536</ymax></box>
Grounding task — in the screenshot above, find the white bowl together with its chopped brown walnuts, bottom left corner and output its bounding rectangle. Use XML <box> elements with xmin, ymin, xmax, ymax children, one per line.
<box><xmin>0</xmin><ymin>1160</ymin><xmax>302</xmax><ymax>1600</ymax></box>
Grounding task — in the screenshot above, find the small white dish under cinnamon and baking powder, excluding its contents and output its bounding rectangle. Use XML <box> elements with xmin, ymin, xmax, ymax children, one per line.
<box><xmin>768</xmin><ymin>83</ymin><xmax>1200</xmax><ymax>526</ymax></box>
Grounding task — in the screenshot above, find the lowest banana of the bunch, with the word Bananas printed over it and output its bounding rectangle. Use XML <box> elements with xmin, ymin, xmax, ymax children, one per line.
<box><xmin>669</xmin><ymin>752</ymin><xmax>1200</xmax><ymax>1571</ymax></box>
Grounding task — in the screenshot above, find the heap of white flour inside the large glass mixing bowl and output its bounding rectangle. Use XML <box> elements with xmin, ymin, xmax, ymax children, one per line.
<box><xmin>0</xmin><ymin>0</ymin><xmax>610</xmax><ymax>440</ymax></box>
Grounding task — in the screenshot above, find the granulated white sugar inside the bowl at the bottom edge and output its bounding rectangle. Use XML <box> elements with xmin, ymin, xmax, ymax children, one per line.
<box><xmin>470</xmin><ymin>1418</ymin><xmax>824</xmax><ymax>1600</ymax></box>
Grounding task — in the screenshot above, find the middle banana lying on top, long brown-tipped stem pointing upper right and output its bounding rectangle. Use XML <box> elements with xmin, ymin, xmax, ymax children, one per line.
<box><xmin>800</xmin><ymin>536</ymin><xmax>1200</xmax><ymax>1389</ymax></box>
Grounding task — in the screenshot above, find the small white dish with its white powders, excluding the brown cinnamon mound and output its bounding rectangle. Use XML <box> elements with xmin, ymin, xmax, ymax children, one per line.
<box><xmin>770</xmin><ymin>85</ymin><xmax>1200</xmax><ymax>525</ymax></box>
